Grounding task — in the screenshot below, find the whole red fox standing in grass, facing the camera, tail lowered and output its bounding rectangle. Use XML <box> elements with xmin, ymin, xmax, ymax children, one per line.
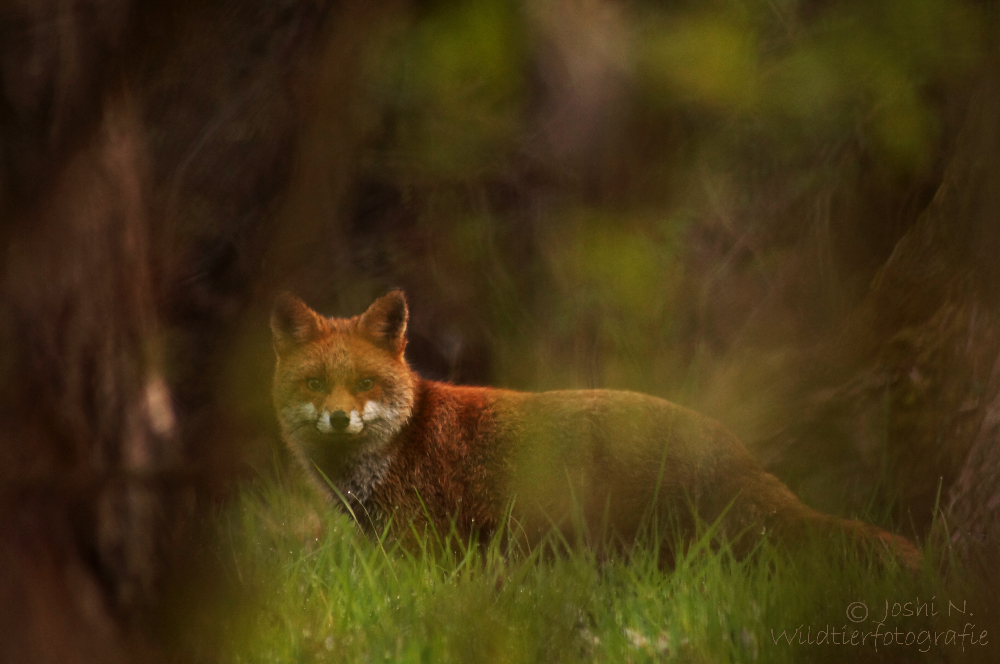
<box><xmin>271</xmin><ymin>291</ymin><xmax>920</xmax><ymax>567</ymax></box>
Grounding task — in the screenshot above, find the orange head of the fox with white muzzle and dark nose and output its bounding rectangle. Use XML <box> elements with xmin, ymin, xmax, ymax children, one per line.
<box><xmin>271</xmin><ymin>291</ymin><xmax>416</xmax><ymax>472</ymax></box>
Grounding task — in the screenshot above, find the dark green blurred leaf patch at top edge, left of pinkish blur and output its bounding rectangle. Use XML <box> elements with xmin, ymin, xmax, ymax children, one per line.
<box><xmin>373</xmin><ymin>0</ymin><xmax>526</xmax><ymax>180</ymax></box>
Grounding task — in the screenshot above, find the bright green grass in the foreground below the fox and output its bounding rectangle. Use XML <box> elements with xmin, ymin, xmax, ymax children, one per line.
<box><xmin>211</xmin><ymin>472</ymin><xmax>1000</xmax><ymax>664</ymax></box>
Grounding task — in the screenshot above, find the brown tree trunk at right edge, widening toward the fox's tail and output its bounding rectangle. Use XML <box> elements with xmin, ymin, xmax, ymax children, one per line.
<box><xmin>763</xmin><ymin>45</ymin><xmax>1000</xmax><ymax>558</ymax></box>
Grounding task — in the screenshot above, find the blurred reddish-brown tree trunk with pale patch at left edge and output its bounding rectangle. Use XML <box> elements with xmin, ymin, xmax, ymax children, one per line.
<box><xmin>2</xmin><ymin>94</ymin><xmax>164</xmax><ymax>661</ymax></box>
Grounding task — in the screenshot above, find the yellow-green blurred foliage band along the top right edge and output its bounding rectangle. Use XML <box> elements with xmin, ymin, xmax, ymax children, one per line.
<box><xmin>636</xmin><ymin>0</ymin><xmax>983</xmax><ymax>170</ymax></box>
